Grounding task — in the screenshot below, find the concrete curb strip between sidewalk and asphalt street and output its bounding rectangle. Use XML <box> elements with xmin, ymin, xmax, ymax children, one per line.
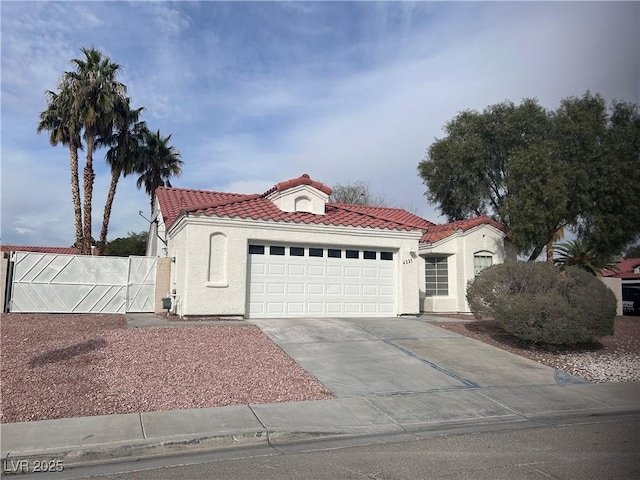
<box><xmin>2</xmin><ymin>406</ymin><xmax>640</xmax><ymax>475</ymax></box>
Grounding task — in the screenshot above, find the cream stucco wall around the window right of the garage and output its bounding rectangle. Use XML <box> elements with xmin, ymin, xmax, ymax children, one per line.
<box><xmin>420</xmin><ymin>225</ymin><xmax>509</xmax><ymax>313</ymax></box>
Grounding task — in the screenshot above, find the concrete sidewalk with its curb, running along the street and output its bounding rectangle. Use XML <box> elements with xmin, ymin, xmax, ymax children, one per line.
<box><xmin>0</xmin><ymin>382</ymin><xmax>640</xmax><ymax>473</ymax></box>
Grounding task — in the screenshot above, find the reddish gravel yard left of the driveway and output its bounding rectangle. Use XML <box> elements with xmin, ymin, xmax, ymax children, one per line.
<box><xmin>1</xmin><ymin>314</ymin><xmax>332</xmax><ymax>423</ymax></box>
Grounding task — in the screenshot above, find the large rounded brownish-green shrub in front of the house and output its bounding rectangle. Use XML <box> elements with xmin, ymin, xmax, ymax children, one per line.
<box><xmin>467</xmin><ymin>262</ymin><xmax>616</xmax><ymax>345</ymax></box>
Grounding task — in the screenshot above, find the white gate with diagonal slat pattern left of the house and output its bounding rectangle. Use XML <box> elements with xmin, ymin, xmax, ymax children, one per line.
<box><xmin>9</xmin><ymin>252</ymin><xmax>156</xmax><ymax>313</ymax></box>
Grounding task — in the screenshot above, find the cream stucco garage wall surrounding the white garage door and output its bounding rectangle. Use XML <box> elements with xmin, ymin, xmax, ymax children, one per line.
<box><xmin>169</xmin><ymin>216</ymin><xmax>420</xmax><ymax>316</ymax></box>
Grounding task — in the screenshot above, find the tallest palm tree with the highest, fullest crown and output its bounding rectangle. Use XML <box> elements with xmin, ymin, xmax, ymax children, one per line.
<box><xmin>65</xmin><ymin>48</ymin><xmax>126</xmax><ymax>255</ymax></box>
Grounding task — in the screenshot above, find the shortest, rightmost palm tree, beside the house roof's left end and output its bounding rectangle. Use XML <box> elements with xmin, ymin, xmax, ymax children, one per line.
<box><xmin>136</xmin><ymin>130</ymin><xmax>184</xmax><ymax>212</ymax></box>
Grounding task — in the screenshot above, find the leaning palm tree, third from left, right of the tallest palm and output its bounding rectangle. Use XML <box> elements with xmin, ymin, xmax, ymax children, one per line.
<box><xmin>98</xmin><ymin>98</ymin><xmax>148</xmax><ymax>249</ymax></box>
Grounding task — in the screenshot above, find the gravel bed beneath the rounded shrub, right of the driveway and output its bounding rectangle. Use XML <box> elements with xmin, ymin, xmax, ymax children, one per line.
<box><xmin>435</xmin><ymin>316</ymin><xmax>640</xmax><ymax>383</ymax></box>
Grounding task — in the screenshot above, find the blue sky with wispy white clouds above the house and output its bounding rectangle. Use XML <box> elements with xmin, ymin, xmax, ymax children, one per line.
<box><xmin>0</xmin><ymin>1</ymin><xmax>640</xmax><ymax>246</ymax></box>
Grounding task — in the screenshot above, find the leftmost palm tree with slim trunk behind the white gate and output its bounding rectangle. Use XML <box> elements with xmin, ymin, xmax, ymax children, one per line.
<box><xmin>37</xmin><ymin>78</ymin><xmax>84</xmax><ymax>250</ymax></box>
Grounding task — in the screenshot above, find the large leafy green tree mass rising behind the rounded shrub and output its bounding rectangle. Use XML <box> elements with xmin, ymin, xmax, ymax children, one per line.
<box><xmin>418</xmin><ymin>92</ymin><xmax>640</xmax><ymax>260</ymax></box>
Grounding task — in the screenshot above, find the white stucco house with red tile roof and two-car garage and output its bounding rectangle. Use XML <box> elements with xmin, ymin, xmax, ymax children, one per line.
<box><xmin>147</xmin><ymin>174</ymin><xmax>510</xmax><ymax>318</ymax></box>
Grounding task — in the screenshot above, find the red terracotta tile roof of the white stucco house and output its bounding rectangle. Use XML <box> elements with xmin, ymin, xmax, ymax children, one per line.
<box><xmin>156</xmin><ymin>174</ymin><xmax>504</xmax><ymax>243</ymax></box>
